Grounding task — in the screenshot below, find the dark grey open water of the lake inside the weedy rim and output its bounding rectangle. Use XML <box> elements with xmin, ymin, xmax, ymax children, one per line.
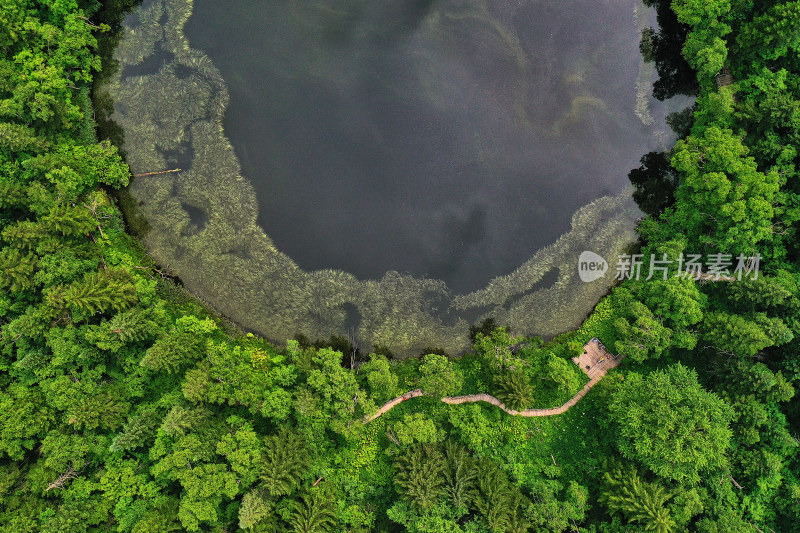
<box><xmin>185</xmin><ymin>0</ymin><xmax>664</xmax><ymax>293</ymax></box>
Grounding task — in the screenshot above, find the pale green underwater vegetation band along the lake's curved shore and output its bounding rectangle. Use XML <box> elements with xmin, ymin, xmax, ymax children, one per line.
<box><xmin>101</xmin><ymin>0</ymin><xmax>637</xmax><ymax>355</ymax></box>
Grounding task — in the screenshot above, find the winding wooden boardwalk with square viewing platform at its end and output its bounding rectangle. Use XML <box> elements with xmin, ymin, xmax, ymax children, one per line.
<box><xmin>364</xmin><ymin>338</ymin><xmax>624</xmax><ymax>422</ymax></box>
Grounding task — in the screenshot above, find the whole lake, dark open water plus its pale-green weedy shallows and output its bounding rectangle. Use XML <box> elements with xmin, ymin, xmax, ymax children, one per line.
<box><xmin>103</xmin><ymin>0</ymin><xmax>674</xmax><ymax>355</ymax></box>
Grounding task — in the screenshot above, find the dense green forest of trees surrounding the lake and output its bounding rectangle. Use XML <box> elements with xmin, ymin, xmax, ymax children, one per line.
<box><xmin>0</xmin><ymin>0</ymin><xmax>800</xmax><ymax>533</ymax></box>
